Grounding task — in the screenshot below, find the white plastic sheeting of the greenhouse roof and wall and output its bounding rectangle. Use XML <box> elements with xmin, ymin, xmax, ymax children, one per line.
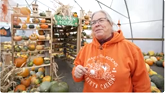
<box><xmin>0</xmin><ymin>0</ymin><xmax>164</xmax><ymax>52</ymax></box>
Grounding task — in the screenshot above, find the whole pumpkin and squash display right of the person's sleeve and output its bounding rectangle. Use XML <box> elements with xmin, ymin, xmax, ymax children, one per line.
<box><xmin>143</xmin><ymin>51</ymin><xmax>164</xmax><ymax>92</ymax></box>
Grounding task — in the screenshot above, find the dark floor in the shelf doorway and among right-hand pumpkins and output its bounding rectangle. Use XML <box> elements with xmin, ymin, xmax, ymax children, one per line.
<box><xmin>55</xmin><ymin>59</ymin><xmax>164</xmax><ymax>92</ymax></box>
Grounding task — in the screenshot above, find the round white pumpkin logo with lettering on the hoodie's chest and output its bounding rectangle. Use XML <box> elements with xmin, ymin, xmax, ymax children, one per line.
<box><xmin>85</xmin><ymin>54</ymin><xmax>118</xmax><ymax>89</ymax></box>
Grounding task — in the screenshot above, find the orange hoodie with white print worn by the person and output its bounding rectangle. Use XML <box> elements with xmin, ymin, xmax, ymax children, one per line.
<box><xmin>72</xmin><ymin>30</ymin><xmax>150</xmax><ymax>92</ymax></box>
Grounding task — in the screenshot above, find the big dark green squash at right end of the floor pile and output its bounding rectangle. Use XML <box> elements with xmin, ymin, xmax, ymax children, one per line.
<box><xmin>50</xmin><ymin>81</ymin><xmax>69</xmax><ymax>92</ymax></box>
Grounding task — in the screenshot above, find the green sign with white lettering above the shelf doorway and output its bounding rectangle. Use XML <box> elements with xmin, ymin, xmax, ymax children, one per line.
<box><xmin>55</xmin><ymin>15</ymin><xmax>78</xmax><ymax>26</ymax></box>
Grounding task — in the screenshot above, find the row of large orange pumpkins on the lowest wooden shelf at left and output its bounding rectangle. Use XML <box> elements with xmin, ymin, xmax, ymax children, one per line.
<box><xmin>14</xmin><ymin>54</ymin><xmax>50</xmax><ymax>68</ymax></box>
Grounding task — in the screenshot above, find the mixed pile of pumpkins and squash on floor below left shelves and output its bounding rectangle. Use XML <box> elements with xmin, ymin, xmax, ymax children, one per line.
<box><xmin>8</xmin><ymin>67</ymin><xmax>69</xmax><ymax>93</ymax></box>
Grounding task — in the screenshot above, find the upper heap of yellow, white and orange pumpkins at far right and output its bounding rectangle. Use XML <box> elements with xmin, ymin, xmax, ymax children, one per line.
<box><xmin>143</xmin><ymin>51</ymin><xmax>164</xmax><ymax>67</ymax></box>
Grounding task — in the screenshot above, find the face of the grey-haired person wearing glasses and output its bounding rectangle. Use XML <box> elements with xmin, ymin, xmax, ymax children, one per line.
<box><xmin>91</xmin><ymin>12</ymin><xmax>112</xmax><ymax>40</ymax></box>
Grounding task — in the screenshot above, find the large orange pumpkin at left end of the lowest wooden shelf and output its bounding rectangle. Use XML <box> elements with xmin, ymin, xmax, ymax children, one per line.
<box><xmin>14</xmin><ymin>57</ymin><xmax>26</xmax><ymax>67</ymax></box>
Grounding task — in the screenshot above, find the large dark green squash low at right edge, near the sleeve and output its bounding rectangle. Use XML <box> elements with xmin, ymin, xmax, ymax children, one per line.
<box><xmin>150</xmin><ymin>74</ymin><xmax>164</xmax><ymax>89</ymax></box>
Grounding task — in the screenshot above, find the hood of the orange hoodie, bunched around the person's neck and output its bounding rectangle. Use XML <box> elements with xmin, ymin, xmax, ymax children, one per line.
<box><xmin>92</xmin><ymin>30</ymin><xmax>125</xmax><ymax>46</ymax></box>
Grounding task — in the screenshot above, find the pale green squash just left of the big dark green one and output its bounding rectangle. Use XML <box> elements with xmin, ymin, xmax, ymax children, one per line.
<box><xmin>39</xmin><ymin>81</ymin><xmax>51</xmax><ymax>92</ymax></box>
